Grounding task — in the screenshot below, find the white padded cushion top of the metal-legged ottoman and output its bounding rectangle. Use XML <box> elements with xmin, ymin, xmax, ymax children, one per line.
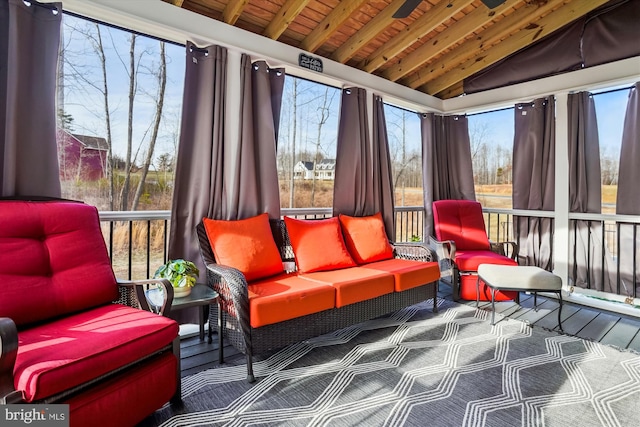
<box><xmin>478</xmin><ymin>264</ymin><xmax>562</xmax><ymax>291</ymax></box>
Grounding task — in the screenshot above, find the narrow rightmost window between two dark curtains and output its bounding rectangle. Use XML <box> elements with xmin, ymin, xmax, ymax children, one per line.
<box><xmin>593</xmin><ymin>89</ymin><xmax>629</xmax><ymax>213</ymax></box>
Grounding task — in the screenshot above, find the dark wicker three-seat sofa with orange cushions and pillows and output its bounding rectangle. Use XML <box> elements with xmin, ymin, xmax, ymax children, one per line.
<box><xmin>197</xmin><ymin>214</ymin><xmax>440</xmax><ymax>382</ymax></box>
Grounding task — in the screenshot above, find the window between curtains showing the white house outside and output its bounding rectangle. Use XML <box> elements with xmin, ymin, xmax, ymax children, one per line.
<box><xmin>277</xmin><ymin>75</ymin><xmax>340</xmax><ymax>208</ymax></box>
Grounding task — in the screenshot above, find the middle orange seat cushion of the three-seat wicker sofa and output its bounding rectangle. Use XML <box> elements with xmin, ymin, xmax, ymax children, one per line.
<box><xmin>300</xmin><ymin>267</ymin><xmax>393</xmax><ymax>308</ymax></box>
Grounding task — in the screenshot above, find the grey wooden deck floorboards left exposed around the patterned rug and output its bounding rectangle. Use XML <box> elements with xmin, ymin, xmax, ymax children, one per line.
<box><xmin>176</xmin><ymin>284</ymin><xmax>640</xmax><ymax>377</ymax></box>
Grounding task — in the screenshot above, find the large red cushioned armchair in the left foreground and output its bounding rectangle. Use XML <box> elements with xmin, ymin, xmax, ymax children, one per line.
<box><xmin>0</xmin><ymin>200</ymin><xmax>180</xmax><ymax>427</ymax></box>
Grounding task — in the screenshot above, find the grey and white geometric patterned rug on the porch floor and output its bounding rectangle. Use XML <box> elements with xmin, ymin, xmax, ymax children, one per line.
<box><xmin>142</xmin><ymin>300</ymin><xmax>640</xmax><ymax>427</ymax></box>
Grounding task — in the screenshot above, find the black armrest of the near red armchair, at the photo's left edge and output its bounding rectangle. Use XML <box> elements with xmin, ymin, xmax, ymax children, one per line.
<box><xmin>0</xmin><ymin>317</ymin><xmax>22</xmax><ymax>404</ymax></box>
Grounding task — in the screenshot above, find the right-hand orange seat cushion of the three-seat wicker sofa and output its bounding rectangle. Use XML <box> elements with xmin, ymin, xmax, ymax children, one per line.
<box><xmin>363</xmin><ymin>258</ymin><xmax>440</xmax><ymax>292</ymax></box>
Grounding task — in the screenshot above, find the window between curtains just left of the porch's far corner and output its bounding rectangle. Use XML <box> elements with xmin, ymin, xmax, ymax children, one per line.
<box><xmin>384</xmin><ymin>104</ymin><xmax>424</xmax><ymax>207</ymax></box>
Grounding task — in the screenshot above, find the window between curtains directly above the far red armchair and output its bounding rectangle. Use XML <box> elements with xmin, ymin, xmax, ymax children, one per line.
<box><xmin>468</xmin><ymin>108</ymin><xmax>515</xmax><ymax>209</ymax></box>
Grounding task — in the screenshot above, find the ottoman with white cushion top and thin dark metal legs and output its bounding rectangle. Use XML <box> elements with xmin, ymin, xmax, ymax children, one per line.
<box><xmin>476</xmin><ymin>264</ymin><xmax>562</xmax><ymax>331</ymax></box>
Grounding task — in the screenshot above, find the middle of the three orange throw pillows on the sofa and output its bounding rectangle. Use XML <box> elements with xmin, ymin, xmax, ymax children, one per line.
<box><xmin>284</xmin><ymin>217</ymin><xmax>356</xmax><ymax>273</ymax></box>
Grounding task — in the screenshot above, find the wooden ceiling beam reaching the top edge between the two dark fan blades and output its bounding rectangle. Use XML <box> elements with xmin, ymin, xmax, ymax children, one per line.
<box><xmin>358</xmin><ymin>0</ymin><xmax>473</xmax><ymax>73</ymax></box>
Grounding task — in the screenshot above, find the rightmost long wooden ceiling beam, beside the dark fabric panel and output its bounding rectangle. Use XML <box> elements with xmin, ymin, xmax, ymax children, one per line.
<box><xmin>423</xmin><ymin>0</ymin><xmax>608</xmax><ymax>94</ymax></box>
